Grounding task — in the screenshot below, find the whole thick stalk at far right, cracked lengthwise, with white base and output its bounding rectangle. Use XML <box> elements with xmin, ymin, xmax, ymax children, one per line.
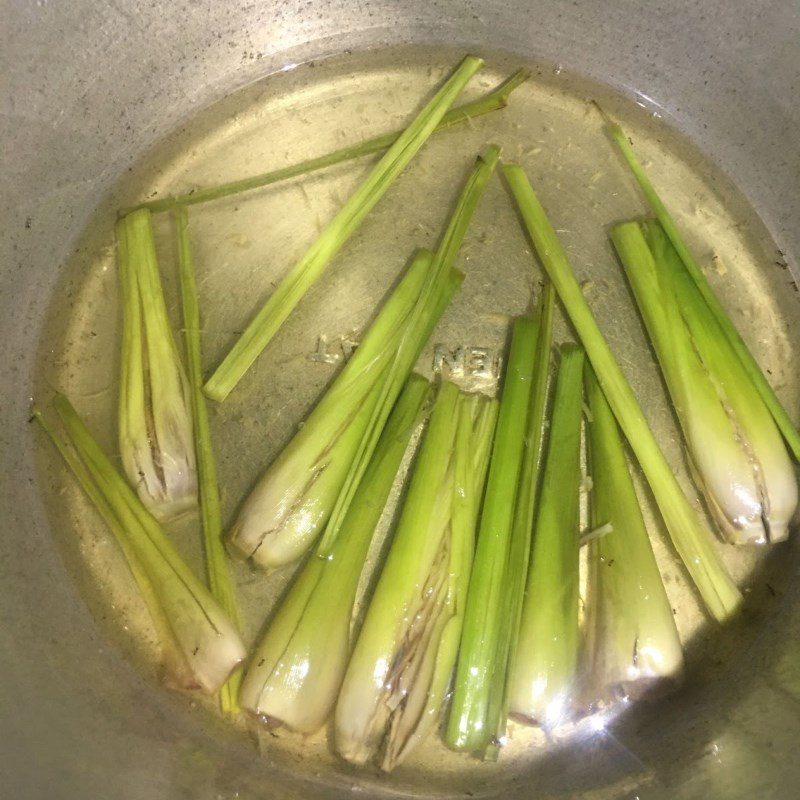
<box><xmin>611</xmin><ymin>221</ymin><xmax>797</xmax><ymax>544</ymax></box>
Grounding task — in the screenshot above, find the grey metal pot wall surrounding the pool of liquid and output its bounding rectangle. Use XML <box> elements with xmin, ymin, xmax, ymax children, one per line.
<box><xmin>0</xmin><ymin>0</ymin><xmax>800</xmax><ymax>800</ymax></box>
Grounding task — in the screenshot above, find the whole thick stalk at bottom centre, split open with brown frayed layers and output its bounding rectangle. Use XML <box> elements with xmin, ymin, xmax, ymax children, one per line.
<box><xmin>335</xmin><ymin>382</ymin><xmax>495</xmax><ymax>769</ymax></box>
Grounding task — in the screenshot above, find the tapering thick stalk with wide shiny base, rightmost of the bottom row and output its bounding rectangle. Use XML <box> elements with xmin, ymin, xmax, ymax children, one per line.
<box><xmin>586</xmin><ymin>369</ymin><xmax>683</xmax><ymax>704</ymax></box>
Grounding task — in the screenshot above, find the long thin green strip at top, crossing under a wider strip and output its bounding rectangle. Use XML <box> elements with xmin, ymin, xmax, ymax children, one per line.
<box><xmin>120</xmin><ymin>69</ymin><xmax>530</xmax><ymax>215</ymax></box>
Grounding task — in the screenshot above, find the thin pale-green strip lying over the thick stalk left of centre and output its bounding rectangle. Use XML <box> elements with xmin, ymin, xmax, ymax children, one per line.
<box><xmin>321</xmin><ymin>145</ymin><xmax>500</xmax><ymax>550</ymax></box>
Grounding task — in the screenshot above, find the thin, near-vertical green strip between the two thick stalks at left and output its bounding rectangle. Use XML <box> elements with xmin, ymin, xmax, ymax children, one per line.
<box><xmin>175</xmin><ymin>208</ymin><xmax>242</xmax><ymax>714</ymax></box>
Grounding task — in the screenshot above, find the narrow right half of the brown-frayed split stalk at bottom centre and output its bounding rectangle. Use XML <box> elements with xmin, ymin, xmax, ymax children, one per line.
<box><xmin>381</xmin><ymin>395</ymin><xmax>499</xmax><ymax>771</ymax></box>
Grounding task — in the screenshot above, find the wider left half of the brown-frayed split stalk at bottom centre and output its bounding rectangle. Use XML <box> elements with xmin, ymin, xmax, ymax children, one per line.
<box><xmin>334</xmin><ymin>382</ymin><xmax>472</xmax><ymax>764</ymax></box>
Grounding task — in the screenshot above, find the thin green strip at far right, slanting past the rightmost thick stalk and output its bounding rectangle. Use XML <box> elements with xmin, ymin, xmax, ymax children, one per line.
<box><xmin>604</xmin><ymin>115</ymin><xmax>800</xmax><ymax>461</ymax></box>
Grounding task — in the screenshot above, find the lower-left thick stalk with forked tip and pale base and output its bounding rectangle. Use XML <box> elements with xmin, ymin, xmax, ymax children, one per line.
<box><xmin>35</xmin><ymin>395</ymin><xmax>245</xmax><ymax>693</ymax></box>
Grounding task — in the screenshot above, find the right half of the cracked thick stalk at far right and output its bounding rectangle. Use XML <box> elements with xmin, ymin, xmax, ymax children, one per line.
<box><xmin>644</xmin><ymin>222</ymin><xmax>798</xmax><ymax>544</ymax></box>
